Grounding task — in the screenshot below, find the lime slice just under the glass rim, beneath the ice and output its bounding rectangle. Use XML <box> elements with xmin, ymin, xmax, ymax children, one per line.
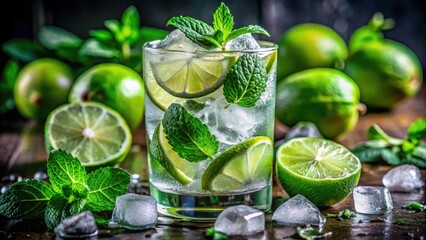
<box><xmin>151</xmin><ymin>57</ymin><xmax>228</xmax><ymax>98</ymax></box>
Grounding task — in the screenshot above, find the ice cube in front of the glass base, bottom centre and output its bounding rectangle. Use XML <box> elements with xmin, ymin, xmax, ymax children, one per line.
<box><xmin>214</xmin><ymin>205</ymin><xmax>265</xmax><ymax>236</ymax></box>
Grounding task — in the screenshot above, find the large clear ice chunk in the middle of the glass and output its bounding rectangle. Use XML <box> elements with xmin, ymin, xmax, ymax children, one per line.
<box><xmin>195</xmin><ymin>97</ymin><xmax>266</xmax><ymax>148</ymax></box>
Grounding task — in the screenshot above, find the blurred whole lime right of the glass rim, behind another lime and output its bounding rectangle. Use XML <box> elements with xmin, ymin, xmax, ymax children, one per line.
<box><xmin>277</xmin><ymin>23</ymin><xmax>348</xmax><ymax>81</ymax></box>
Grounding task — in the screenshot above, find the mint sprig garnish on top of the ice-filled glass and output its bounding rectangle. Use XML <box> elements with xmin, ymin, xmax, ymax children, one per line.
<box><xmin>166</xmin><ymin>3</ymin><xmax>269</xmax><ymax>50</ymax></box>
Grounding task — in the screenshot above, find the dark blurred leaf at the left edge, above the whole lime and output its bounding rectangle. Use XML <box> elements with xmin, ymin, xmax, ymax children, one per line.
<box><xmin>2</xmin><ymin>38</ymin><xmax>47</xmax><ymax>62</ymax></box>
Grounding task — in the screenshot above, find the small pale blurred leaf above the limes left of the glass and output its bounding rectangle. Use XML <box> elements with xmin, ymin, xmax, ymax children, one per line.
<box><xmin>79</xmin><ymin>38</ymin><xmax>121</xmax><ymax>58</ymax></box>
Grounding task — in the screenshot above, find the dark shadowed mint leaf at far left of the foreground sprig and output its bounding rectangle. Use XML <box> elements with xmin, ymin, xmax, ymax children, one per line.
<box><xmin>0</xmin><ymin>179</ymin><xmax>55</xmax><ymax>218</ymax></box>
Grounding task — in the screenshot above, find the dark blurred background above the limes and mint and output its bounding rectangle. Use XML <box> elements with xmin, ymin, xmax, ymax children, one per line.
<box><xmin>0</xmin><ymin>0</ymin><xmax>426</xmax><ymax>70</ymax></box>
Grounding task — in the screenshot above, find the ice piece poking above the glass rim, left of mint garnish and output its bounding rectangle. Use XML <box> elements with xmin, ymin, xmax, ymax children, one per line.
<box><xmin>158</xmin><ymin>29</ymin><xmax>203</xmax><ymax>52</ymax></box>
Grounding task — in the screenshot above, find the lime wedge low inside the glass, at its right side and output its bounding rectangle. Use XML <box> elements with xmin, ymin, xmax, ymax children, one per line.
<box><xmin>201</xmin><ymin>136</ymin><xmax>273</xmax><ymax>192</ymax></box>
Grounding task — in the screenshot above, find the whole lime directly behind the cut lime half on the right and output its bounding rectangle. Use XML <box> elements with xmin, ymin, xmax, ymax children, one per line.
<box><xmin>276</xmin><ymin>68</ymin><xmax>360</xmax><ymax>138</ymax></box>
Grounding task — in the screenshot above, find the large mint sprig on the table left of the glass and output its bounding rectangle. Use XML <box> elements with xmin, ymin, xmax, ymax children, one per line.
<box><xmin>0</xmin><ymin>150</ymin><xmax>130</xmax><ymax>229</ymax></box>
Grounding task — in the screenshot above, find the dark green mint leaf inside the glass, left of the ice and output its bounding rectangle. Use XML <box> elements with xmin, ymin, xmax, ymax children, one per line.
<box><xmin>162</xmin><ymin>103</ymin><xmax>219</xmax><ymax>162</ymax></box>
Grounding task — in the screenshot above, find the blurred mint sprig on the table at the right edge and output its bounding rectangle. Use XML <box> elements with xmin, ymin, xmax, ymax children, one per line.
<box><xmin>352</xmin><ymin>118</ymin><xmax>426</xmax><ymax>167</ymax></box>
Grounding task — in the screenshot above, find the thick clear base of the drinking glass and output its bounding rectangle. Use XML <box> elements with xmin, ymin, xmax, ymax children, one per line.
<box><xmin>150</xmin><ymin>184</ymin><xmax>272</xmax><ymax>222</ymax></box>
